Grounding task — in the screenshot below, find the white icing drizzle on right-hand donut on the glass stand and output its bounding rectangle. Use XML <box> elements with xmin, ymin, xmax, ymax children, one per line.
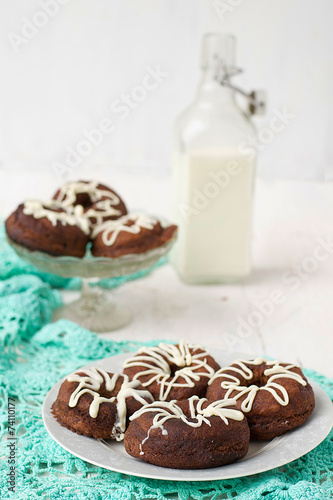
<box><xmin>92</xmin><ymin>214</ymin><xmax>157</xmax><ymax>247</ymax></box>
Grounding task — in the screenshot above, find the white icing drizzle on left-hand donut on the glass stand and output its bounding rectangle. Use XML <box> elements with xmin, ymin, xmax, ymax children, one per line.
<box><xmin>23</xmin><ymin>200</ymin><xmax>90</xmax><ymax>234</ymax></box>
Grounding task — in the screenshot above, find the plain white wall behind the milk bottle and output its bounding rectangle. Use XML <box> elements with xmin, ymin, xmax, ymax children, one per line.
<box><xmin>0</xmin><ymin>0</ymin><xmax>333</xmax><ymax>180</ymax></box>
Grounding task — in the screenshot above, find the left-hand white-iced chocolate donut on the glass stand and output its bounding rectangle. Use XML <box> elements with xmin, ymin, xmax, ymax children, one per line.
<box><xmin>5</xmin><ymin>200</ymin><xmax>90</xmax><ymax>257</ymax></box>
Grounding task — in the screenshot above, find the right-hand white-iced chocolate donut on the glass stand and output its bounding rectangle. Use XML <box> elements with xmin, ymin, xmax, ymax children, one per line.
<box><xmin>91</xmin><ymin>214</ymin><xmax>177</xmax><ymax>258</ymax></box>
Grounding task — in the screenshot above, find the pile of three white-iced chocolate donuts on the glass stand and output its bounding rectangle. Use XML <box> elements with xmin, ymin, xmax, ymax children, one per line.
<box><xmin>5</xmin><ymin>181</ymin><xmax>177</xmax><ymax>258</ymax></box>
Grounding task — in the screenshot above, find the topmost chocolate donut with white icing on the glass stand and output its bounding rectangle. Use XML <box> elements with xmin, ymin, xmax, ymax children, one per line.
<box><xmin>53</xmin><ymin>181</ymin><xmax>127</xmax><ymax>225</ymax></box>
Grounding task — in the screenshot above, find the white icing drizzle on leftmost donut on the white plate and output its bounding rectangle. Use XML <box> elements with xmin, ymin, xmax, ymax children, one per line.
<box><xmin>67</xmin><ymin>367</ymin><xmax>153</xmax><ymax>440</ymax></box>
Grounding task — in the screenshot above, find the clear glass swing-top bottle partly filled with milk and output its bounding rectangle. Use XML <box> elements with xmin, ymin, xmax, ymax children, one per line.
<box><xmin>170</xmin><ymin>34</ymin><xmax>256</xmax><ymax>283</ymax></box>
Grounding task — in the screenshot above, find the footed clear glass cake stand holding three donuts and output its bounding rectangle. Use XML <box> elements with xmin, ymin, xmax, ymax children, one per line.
<box><xmin>7</xmin><ymin>234</ymin><xmax>176</xmax><ymax>333</ymax></box>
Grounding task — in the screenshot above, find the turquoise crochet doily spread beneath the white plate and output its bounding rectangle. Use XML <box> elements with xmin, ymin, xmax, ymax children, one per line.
<box><xmin>0</xmin><ymin>225</ymin><xmax>333</xmax><ymax>500</ymax></box>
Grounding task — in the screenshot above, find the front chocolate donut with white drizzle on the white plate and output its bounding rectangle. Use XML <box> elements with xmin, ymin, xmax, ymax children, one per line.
<box><xmin>124</xmin><ymin>396</ymin><xmax>250</xmax><ymax>469</ymax></box>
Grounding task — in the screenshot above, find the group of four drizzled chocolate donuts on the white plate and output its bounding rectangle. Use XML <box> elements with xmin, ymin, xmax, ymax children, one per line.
<box><xmin>52</xmin><ymin>341</ymin><xmax>315</xmax><ymax>469</ymax></box>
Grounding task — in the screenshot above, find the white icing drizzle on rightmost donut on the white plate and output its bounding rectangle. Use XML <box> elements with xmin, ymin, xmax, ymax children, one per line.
<box><xmin>209</xmin><ymin>358</ymin><xmax>307</xmax><ymax>412</ymax></box>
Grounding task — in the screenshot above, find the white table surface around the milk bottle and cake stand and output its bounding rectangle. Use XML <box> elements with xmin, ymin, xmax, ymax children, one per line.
<box><xmin>0</xmin><ymin>168</ymin><xmax>333</xmax><ymax>377</ymax></box>
